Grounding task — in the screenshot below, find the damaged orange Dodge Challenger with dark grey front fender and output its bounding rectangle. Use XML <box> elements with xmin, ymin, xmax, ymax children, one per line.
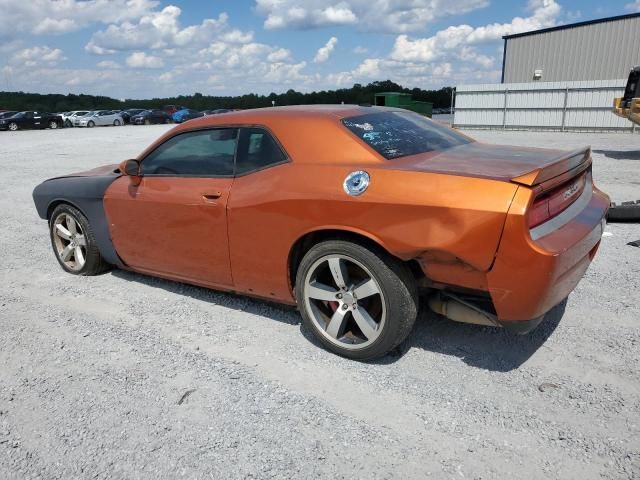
<box><xmin>33</xmin><ymin>105</ymin><xmax>609</xmax><ymax>359</ymax></box>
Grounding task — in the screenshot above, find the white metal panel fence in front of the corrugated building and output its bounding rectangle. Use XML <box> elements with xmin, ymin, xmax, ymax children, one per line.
<box><xmin>453</xmin><ymin>79</ymin><xmax>640</xmax><ymax>132</ymax></box>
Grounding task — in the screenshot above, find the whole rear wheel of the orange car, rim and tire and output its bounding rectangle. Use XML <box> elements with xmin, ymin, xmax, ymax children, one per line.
<box><xmin>296</xmin><ymin>240</ymin><xmax>418</xmax><ymax>360</ymax></box>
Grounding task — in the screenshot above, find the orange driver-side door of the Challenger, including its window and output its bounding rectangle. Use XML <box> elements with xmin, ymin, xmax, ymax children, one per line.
<box><xmin>104</xmin><ymin>128</ymin><xmax>238</xmax><ymax>287</ymax></box>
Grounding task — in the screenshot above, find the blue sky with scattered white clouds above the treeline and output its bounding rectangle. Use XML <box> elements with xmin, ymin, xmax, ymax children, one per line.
<box><xmin>0</xmin><ymin>0</ymin><xmax>640</xmax><ymax>98</ymax></box>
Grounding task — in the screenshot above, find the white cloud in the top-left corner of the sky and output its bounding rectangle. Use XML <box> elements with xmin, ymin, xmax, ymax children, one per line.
<box><xmin>0</xmin><ymin>0</ymin><xmax>159</xmax><ymax>38</ymax></box>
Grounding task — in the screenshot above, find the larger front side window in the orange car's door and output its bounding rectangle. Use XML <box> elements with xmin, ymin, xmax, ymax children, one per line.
<box><xmin>142</xmin><ymin>128</ymin><xmax>238</xmax><ymax>177</ymax></box>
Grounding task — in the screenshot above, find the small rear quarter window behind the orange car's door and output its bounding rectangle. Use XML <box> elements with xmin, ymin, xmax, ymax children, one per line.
<box><xmin>236</xmin><ymin>128</ymin><xmax>287</xmax><ymax>175</ymax></box>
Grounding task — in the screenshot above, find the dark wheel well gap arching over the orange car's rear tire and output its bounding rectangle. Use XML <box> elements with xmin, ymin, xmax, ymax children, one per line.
<box><xmin>289</xmin><ymin>230</ymin><xmax>424</xmax><ymax>290</ymax></box>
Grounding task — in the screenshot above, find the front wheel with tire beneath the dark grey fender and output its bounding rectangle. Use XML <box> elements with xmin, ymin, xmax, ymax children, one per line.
<box><xmin>49</xmin><ymin>204</ymin><xmax>109</xmax><ymax>275</ymax></box>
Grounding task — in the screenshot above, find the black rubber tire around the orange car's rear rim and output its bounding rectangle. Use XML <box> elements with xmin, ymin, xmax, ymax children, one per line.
<box><xmin>295</xmin><ymin>240</ymin><xmax>419</xmax><ymax>360</ymax></box>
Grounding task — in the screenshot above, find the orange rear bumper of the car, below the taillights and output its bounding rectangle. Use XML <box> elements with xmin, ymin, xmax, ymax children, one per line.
<box><xmin>487</xmin><ymin>178</ymin><xmax>609</xmax><ymax>333</ymax></box>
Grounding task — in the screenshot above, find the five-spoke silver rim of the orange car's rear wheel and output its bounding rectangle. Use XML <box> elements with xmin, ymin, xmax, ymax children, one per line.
<box><xmin>303</xmin><ymin>254</ymin><xmax>387</xmax><ymax>350</ymax></box>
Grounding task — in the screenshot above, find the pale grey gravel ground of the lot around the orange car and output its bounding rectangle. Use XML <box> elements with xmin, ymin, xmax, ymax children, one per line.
<box><xmin>0</xmin><ymin>126</ymin><xmax>640</xmax><ymax>480</ymax></box>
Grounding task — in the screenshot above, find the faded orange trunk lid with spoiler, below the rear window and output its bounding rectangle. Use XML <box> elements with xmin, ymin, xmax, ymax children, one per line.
<box><xmin>390</xmin><ymin>142</ymin><xmax>591</xmax><ymax>186</ymax></box>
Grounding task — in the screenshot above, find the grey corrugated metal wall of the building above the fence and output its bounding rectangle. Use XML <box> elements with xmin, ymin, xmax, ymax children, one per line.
<box><xmin>503</xmin><ymin>16</ymin><xmax>640</xmax><ymax>83</ymax></box>
